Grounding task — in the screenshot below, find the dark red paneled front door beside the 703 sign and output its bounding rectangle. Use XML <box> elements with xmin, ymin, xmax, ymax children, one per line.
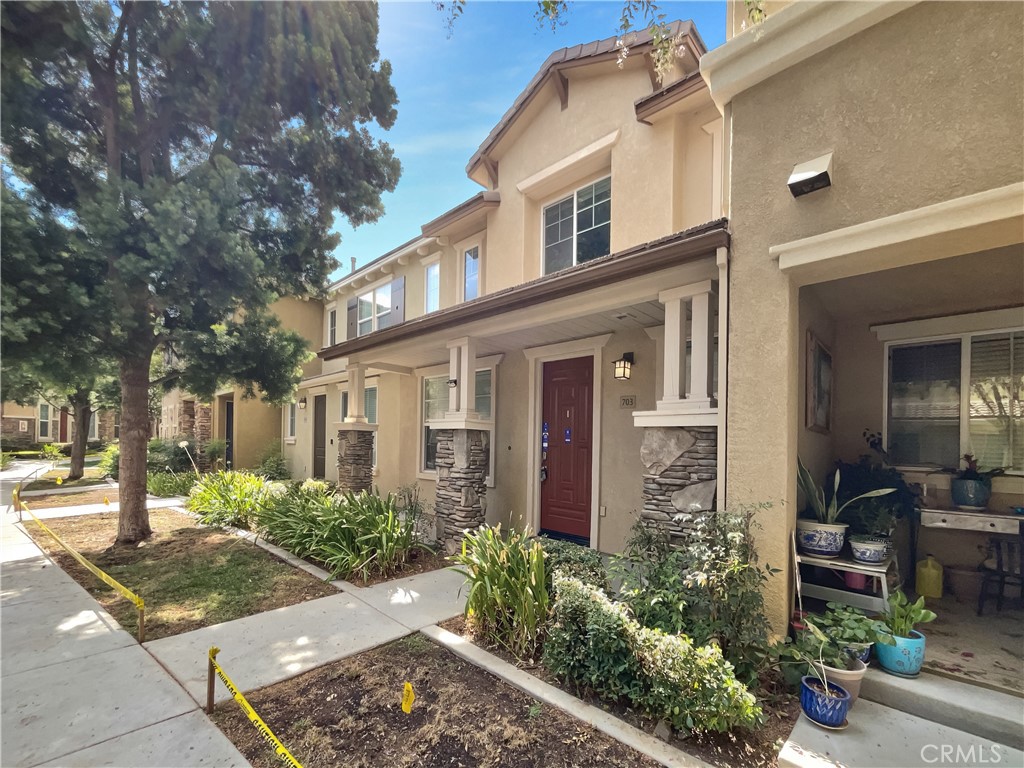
<box><xmin>541</xmin><ymin>357</ymin><xmax>594</xmax><ymax>542</ymax></box>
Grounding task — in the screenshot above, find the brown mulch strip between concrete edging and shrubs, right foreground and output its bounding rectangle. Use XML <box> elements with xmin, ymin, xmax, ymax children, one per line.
<box><xmin>439</xmin><ymin>616</ymin><xmax>800</xmax><ymax>768</ymax></box>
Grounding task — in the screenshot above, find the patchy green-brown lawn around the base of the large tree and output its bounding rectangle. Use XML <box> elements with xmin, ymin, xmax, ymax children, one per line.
<box><xmin>25</xmin><ymin>509</ymin><xmax>338</xmax><ymax>640</ymax></box>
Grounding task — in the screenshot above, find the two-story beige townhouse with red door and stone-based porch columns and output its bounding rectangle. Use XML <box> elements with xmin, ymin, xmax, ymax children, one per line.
<box><xmin>285</xmin><ymin>22</ymin><xmax>729</xmax><ymax>551</ymax></box>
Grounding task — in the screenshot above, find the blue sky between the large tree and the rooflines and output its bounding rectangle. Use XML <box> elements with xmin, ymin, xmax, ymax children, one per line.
<box><xmin>335</xmin><ymin>0</ymin><xmax>725</xmax><ymax>278</ymax></box>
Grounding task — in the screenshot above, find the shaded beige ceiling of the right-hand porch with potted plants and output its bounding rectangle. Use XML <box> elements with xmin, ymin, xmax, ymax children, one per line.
<box><xmin>803</xmin><ymin>245</ymin><xmax>1024</xmax><ymax>323</ymax></box>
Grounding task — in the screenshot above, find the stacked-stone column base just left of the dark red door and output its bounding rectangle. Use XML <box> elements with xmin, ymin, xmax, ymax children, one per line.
<box><xmin>434</xmin><ymin>429</ymin><xmax>489</xmax><ymax>554</ymax></box>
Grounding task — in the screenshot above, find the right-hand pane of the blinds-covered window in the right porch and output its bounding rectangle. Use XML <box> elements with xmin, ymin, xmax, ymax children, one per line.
<box><xmin>970</xmin><ymin>331</ymin><xmax>1024</xmax><ymax>472</ymax></box>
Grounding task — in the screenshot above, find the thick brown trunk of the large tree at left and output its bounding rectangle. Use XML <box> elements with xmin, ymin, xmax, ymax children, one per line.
<box><xmin>118</xmin><ymin>354</ymin><xmax>153</xmax><ymax>544</ymax></box>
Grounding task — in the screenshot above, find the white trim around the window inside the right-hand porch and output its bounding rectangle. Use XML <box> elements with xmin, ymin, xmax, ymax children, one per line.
<box><xmin>871</xmin><ymin>310</ymin><xmax>1024</xmax><ymax>480</ymax></box>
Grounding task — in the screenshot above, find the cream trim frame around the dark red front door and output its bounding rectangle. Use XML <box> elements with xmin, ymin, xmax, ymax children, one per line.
<box><xmin>523</xmin><ymin>334</ymin><xmax>612</xmax><ymax>549</ymax></box>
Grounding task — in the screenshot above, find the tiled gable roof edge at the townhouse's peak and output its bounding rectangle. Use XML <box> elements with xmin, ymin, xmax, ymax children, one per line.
<box><xmin>466</xmin><ymin>20</ymin><xmax>708</xmax><ymax>180</ymax></box>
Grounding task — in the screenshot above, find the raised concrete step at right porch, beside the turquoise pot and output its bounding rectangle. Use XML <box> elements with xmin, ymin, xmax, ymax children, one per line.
<box><xmin>860</xmin><ymin>669</ymin><xmax>1024</xmax><ymax>750</ymax></box>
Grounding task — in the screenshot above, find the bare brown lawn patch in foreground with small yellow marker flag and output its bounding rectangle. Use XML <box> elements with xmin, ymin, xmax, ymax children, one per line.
<box><xmin>213</xmin><ymin>635</ymin><xmax>657</xmax><ymax>768</ymax></box>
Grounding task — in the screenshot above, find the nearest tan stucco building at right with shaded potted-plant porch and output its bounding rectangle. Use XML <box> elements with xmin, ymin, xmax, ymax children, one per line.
<box><xmin>700</xmin><ymin>2</ymin><xmax>1024</xmax><ymax>630</ymax></box>
